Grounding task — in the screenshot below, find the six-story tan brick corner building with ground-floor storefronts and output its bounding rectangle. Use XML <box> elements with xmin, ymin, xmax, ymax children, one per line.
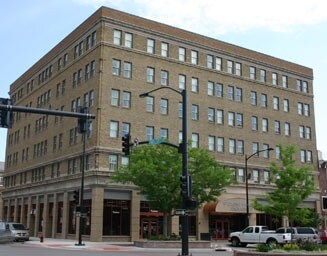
<box><xmin>2</xmin><ymin>7</ymin><xmax>321</xmax><ymax>241</ymax></box>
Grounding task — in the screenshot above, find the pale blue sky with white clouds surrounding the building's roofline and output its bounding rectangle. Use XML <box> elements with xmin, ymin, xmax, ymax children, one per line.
<box><xmin>0</xmin><ymin>0</ymin><xmax>327</xmax><ymax>161</ymax></box>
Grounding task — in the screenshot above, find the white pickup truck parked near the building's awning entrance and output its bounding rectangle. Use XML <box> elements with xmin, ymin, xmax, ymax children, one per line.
<box><xmin>229</xmin><ymin>226</ymin><xmax>291</xmax><ymax>246</ymax></box>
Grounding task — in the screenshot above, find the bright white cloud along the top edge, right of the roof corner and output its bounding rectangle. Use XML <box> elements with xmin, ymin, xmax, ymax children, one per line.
<box><xmin>74</xmin><ymin>0</ymin><xmax>327</xmax><ymax>35</ymax></box>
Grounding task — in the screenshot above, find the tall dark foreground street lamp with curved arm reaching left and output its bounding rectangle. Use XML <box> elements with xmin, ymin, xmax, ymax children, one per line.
<box><xmin>139</xmin><ymin>87</ymin><xmax>191</xmax><ymax>256</ymax></box>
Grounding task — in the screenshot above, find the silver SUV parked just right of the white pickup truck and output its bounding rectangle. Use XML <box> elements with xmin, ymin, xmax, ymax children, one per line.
<box><xmin>276</xmin><ymin>227</ymin><xmax>321</xmax><ymax>243</ymax></box>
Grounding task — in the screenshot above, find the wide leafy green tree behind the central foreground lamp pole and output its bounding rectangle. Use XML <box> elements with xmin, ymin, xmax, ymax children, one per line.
<box><xmin>111</xmin><ymin>145</ymin><xmax>234</xmax><ymax>235</ymax></box>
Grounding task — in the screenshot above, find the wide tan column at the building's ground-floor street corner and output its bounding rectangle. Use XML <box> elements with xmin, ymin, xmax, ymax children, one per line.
<box><xmin>90</xmin><ymin>187</ymin><xmax>104</xmax><ymax>242</ymax></box>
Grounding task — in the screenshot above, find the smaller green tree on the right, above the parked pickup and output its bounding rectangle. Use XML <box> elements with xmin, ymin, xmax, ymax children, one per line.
<box><xmin>253</xmin><ymin>145</ymin><xmax>315</xmax><ymax>226</ymax></box>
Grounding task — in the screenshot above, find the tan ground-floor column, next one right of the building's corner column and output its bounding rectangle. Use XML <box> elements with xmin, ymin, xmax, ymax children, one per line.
<box><xmin>131</xmin><ymin>190</ymin><xmax>141</xmax><ymax>241</ymax></box>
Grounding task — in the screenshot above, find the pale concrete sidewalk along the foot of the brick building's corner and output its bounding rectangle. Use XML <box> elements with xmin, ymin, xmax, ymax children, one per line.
<box><xmin>22</xmin><ymin>237</ymin><xmax>232</xmax><ymax>252</ymax></box>
